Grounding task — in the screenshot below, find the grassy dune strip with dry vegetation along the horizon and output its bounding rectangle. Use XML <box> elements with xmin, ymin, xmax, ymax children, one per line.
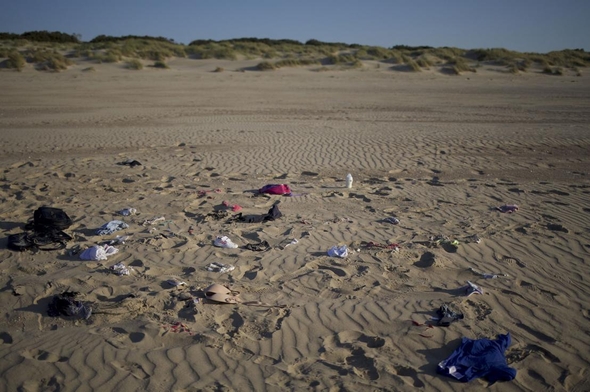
<box><xmin>0</xmin><ymin>31</ymin><xmax>590</xmax><ymax>76</ymax></box>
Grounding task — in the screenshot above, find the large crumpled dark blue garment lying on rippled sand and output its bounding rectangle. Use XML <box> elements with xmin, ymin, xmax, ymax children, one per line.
<box><xmin>437</xmin><ymin>333</ymin><xmax>516</xmax><ymax>383</ymax></box>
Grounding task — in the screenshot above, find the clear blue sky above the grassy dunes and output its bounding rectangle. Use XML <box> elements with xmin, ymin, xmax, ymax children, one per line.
<box><xmin>0</xmin><ymin>0</ymin><xmax>590</xmax><ymax>53</ymax></box>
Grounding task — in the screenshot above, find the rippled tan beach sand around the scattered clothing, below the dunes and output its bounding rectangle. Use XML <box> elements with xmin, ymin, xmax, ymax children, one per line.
<box><xmin>0</xmin><ymin>59</ymin><xmax>590</xmax><ymax>391</ymax></box>
